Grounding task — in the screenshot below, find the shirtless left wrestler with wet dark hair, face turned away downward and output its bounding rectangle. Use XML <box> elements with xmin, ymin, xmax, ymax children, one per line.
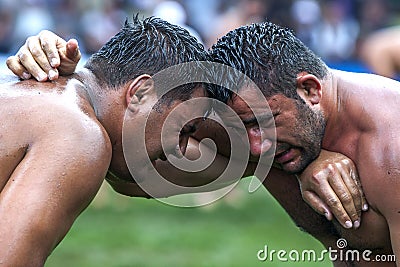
<box><xmin>0</xmin><ymin>17</ymin><xmax>225</xmax><ymax>266</ymax></box>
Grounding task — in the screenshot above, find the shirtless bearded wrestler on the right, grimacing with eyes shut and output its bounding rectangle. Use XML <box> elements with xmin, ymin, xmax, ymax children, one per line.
<box><xmin>211</xmin><ymin>22</ymin><xmax>400</xmax><ymax>266</ymax></box>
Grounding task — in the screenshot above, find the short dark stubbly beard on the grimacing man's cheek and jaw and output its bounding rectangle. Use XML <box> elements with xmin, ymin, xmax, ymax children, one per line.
<box><xmin>287</xmin><ymin>101</ymin><xmax>326</xmax><ymax>174</ymax></box>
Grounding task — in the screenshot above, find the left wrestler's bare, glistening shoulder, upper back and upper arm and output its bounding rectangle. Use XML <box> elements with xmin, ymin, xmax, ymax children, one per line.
<box><xmin>0</xmin><ymin>74</ymin><xmax>111</xmax><ymax>266</ymax></box>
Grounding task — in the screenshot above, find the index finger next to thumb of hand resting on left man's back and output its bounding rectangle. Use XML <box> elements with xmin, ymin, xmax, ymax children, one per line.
<box><xmin>38</xmin><ymin>30</ymin><xmax>65</xmax><ymax>68</ymax></box>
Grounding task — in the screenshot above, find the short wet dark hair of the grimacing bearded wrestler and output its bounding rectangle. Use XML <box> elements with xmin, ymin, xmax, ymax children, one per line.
<box><xmin>210</xmin><ymin>22</ymin><xmax>328</xmax><ymax>100</ymax></box>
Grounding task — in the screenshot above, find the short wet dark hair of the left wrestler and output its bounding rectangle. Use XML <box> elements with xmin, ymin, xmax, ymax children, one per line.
<box><xmin>85</xmin><ymin>15</ymin><xmax>216</xmax><ymax>103</ymax></box>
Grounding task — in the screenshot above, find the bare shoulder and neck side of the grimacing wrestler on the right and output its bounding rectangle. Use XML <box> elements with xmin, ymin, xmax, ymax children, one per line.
<box><xmin>321</xmin><ymin>71</ymin><xmax>400</xmax><ymax>264</ymax></box>
